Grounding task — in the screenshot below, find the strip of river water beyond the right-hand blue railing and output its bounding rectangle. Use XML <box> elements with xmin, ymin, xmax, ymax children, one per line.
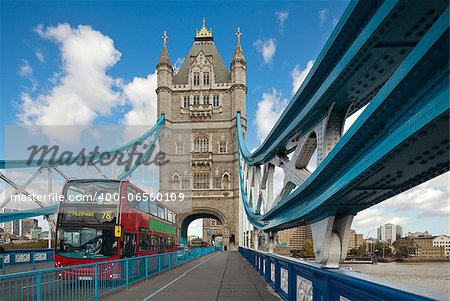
<box><xmin>341</xmin><ymin>262</ymin><xmax>450</xmax><ymax>293</ymax></box>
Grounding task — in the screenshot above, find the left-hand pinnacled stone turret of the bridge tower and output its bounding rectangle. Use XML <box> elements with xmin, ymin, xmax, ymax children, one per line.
<box><xmin>156</xmin><ymin>31</ymin><xmax>173</xmax><ymax>121</ymax></box>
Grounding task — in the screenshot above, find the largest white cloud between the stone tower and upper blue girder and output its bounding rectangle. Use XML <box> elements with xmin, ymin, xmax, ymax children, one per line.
<box><xmin>254</xmin><ymin>89</ymin><xmax>288</xmax><ymax>142</ymax></box>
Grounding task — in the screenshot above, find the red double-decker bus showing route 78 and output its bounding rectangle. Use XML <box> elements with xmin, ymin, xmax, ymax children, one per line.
<box><xmin>55</xmin><ymin>179</ymin><xmax>178</xmax><ymax>267</ymax></box>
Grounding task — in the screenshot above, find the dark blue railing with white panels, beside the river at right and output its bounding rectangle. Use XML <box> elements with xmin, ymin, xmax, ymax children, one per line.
<box><xmin>239</xmin><ymin>247</ymin><xmax>450</xmax><ymax>301</ymax></box>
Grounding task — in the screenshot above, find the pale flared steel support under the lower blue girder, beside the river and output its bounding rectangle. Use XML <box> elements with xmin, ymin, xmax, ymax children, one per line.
<box><xmin>311</xmin><ymin>215</ymin><xmax>354</xmax><ymax>268</ymax></box>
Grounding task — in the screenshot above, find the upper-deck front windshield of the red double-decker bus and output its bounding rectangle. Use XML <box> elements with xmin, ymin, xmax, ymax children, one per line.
<box><xmin>64</xmin><ymin>181</ymin><xmax>120</xmax><ymax>205</ymax></box>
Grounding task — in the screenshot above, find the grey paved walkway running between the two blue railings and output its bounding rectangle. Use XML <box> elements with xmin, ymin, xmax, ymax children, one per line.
<box><xmin>102</xmin><ymin>252</ymin><xmax>280</xmax><ymax>301</ymax></box>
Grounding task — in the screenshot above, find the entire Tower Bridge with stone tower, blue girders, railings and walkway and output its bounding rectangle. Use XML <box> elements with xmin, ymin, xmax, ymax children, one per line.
<box><xmin>0</xmin><ymin>0</ymin><xmax>450</xmax><ymax>300</ymax></box>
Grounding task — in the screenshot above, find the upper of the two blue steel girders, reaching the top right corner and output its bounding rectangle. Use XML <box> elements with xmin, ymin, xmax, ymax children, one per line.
<box><xmin>243</xmin><ymin>1</ymin><xmax>448</xmax><ymax>165</ymax></box>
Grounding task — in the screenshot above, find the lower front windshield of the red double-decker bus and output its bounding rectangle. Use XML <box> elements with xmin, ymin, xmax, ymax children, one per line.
<box><xmin>56</xmin><ymin>227</ymin><xmax>117</xmax><ymax>259</ymax></box>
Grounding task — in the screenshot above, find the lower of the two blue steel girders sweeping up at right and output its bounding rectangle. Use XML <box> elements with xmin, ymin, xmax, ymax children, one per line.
<box><xmin>254</xmin><ymin>9</ymin><xmax>449</xmax><ymax>230</ymax></box>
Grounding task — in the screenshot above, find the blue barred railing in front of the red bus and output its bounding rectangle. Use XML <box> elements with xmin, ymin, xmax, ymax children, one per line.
<box><xmin>0</xmin><ymin>247</ymin><xmax>214</xmax><ymax>301</ymax></box>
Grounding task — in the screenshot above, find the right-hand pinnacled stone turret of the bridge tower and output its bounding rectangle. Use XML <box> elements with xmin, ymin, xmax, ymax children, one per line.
<box><xmin>231</xmin><ymin>27</ymin><xmax>247</xmax><ymax>118</ymax></box>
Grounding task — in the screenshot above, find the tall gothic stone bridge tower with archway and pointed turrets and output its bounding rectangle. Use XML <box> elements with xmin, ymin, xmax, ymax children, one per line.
<box><xmin>156</xmin><ymin>19</ymin><xmax>247</xmax><ymax>250</ymax></box>
